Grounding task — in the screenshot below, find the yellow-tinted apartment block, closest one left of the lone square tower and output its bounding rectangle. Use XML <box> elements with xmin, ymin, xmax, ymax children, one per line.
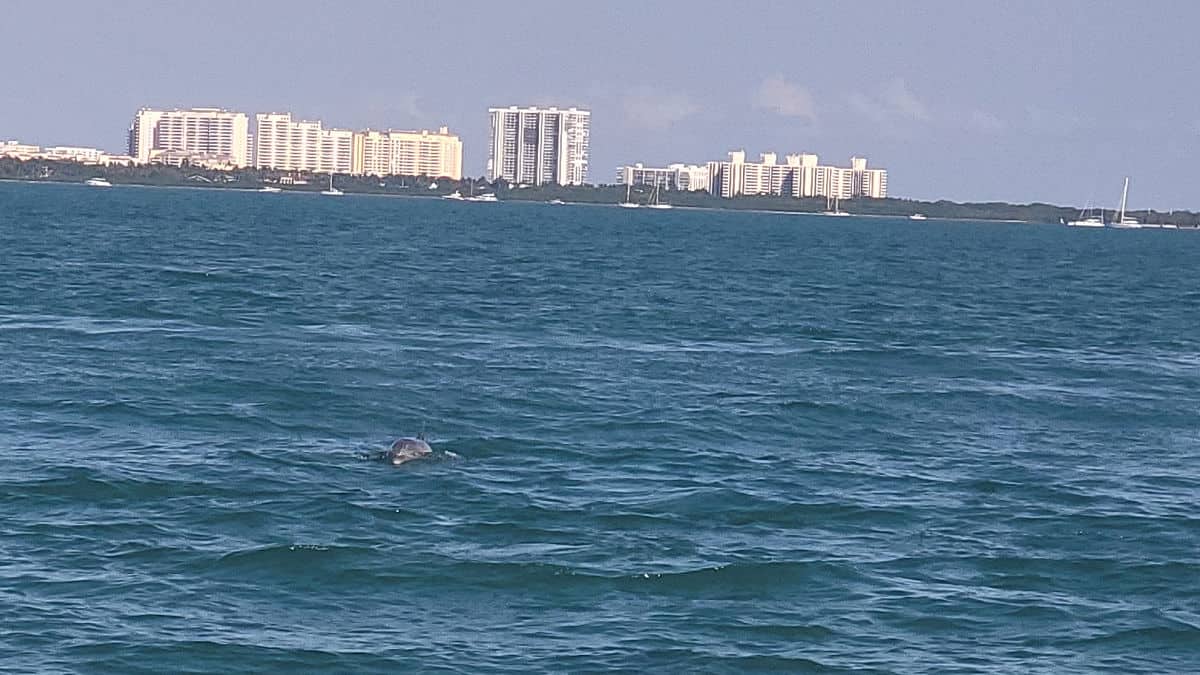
<box><xmin>350</xmin><ymin>126</ymin><xmax>462</xmax><ymax>180</ymax></box>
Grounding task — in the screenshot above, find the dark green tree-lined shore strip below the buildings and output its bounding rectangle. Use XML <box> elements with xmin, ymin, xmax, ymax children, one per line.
<box><xmin>0</xmin><ymin>159</ymin><xmax>1200</xmax><ymax>228</ymax></box>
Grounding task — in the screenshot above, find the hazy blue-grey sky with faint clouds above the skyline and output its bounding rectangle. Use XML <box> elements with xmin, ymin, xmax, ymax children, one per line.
<box><xmin>7</xmin><ymin>0</ymin><xmax>1200</xmax><ymax>209</ymax></box>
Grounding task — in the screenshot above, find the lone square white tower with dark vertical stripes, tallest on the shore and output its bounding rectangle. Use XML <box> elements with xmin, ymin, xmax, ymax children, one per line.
<box><xmin>487</xmin><ymin>106</ymin><xmax>592</xmax><ymax>185</ymax></box>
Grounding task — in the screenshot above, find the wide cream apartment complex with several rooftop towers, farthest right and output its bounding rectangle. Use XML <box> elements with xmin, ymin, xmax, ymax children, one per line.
<box><xmin>708</xmin><ymin>150</ymin><xmax>888</xmax><ymax>199</ymax></box>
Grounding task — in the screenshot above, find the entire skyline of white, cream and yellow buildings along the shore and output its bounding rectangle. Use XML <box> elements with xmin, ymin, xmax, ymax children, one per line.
<box><xmin>0</xmin><ymin>106</ymin><xmax>888</xmax><ymax>199</ymax></box>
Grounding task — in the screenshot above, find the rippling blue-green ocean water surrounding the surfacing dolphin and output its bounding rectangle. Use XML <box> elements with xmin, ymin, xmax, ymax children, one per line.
<box><xmin>0</xmin><ymin>184</ymin><xmax>1200</xmax><ymax>673</ymax></box>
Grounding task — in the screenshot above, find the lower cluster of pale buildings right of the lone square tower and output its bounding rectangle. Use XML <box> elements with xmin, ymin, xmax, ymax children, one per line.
<box><xmin>617</xmin><ymin>150</ymin><xmax>888</xmax><ymax>199</ymax></box>
